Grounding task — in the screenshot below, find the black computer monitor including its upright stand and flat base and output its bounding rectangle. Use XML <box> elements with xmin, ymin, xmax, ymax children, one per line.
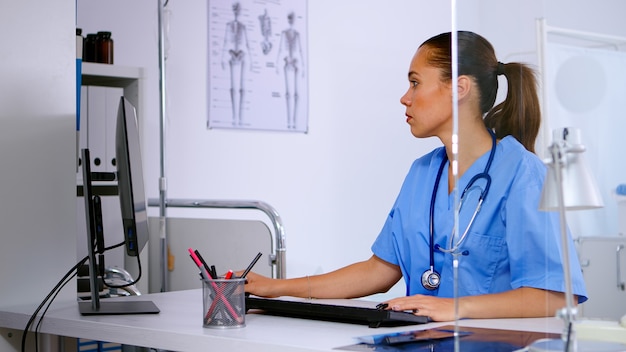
<box><xmin>78</xmin><ymin>97</ymin><xmax>159</xmax><ymax>315</ymax></box>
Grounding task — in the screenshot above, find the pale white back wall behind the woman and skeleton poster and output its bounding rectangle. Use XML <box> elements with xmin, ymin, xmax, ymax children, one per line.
<box><xmin>78</xmin><ymin>0</ymin><xmax>626</xmax><ymax>296</ymax></box>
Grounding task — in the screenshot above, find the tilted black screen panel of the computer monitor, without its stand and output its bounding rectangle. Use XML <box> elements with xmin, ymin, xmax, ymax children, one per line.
<box><xmin>115</xmin><ymin>96</ymin><xmax>148</xmax><ymax>256</ymax></box>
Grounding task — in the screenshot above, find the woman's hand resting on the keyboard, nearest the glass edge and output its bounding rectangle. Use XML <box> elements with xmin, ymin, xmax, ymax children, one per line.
<box><xmin>385</xmin><ymin>295</ymin><xmax>454</xmax><ymax>321</ymax></box>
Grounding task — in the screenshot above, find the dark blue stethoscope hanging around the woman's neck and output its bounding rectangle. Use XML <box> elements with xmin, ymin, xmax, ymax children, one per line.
<box><xmin>422</xmin><ymin>130</ymin><xmax>496</xmax><ymax>291</ymax></box>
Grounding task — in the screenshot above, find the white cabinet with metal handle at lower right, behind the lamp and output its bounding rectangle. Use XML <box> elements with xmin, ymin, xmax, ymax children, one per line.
<box><xmin>576</xmin><ymin>236</ymin><xmax>626</xmax><ymax>320</ymax></box>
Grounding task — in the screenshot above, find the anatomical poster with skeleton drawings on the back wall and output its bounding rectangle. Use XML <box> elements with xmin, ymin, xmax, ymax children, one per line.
<box><xmin>207</xmin><ymin>0</ymin><xmax>308</xmax><ymax>132</ymax></box>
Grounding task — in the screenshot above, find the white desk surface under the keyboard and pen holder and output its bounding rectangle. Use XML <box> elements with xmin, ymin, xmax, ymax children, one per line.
<box><xmin>0</xmin><ymin>289</ymin><xmax>562</xmax><ymax>352</ymax></box>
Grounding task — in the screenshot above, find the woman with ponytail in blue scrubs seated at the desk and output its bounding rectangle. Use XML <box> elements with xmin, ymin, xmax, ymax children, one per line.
<box><xmin>240</xmin><ymin>31</ymin><xmax>587</xmax><ymax>321</ymax></box>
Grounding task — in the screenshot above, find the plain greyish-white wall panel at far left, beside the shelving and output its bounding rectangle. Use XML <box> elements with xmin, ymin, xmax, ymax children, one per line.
<box><xmin>0</xmin><ymin>0</ymin><xmax>76</xmax><ymax>351</ymax></box>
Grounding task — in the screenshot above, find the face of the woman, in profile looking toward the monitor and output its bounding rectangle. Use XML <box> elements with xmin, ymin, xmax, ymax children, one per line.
<box><xmin>400</xmin><ymin>47</ymin><xmax>452</xmax><ymax>138</ymax></box>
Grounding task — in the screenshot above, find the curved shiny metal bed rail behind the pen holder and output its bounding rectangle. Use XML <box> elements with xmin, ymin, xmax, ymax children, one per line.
<box><xmin>148</xmin><ymin>199</ymin><xmax>287</xmax><ymax>279</ymax></box>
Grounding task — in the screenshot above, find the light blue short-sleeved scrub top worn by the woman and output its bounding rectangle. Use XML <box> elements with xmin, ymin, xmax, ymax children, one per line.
<box><xmin>372</xmin><ymin>136</ymin><xmax>587</xmax><ymax>303</ymax></box>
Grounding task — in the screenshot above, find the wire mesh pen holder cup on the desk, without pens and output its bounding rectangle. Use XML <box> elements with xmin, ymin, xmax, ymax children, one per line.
<box><xmin>201</xmin><ymin>278</ymin><xmax>246</xmax><ymax>329</ymax></box>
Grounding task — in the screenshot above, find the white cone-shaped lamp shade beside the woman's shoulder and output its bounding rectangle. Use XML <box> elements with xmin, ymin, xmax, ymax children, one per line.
<box><xmin>539</xmin><ymin>127</ymin><xmax>604</xmax><ymax>211</ymax></box>
